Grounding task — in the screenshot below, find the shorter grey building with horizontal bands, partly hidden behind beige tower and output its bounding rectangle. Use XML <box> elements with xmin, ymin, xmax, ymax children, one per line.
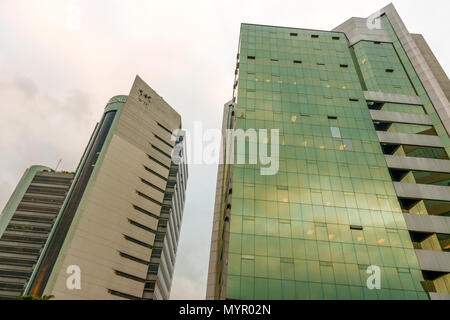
<box><xmin>0</xmin><ymin>166</ymin><xmax>74</xmax><ymax>299</ymax></box>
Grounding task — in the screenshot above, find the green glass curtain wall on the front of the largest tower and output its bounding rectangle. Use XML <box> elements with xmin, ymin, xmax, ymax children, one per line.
<box><xmin>221</xmin><ymin>25</ymin><xmax>427</xmax><ymax>299</ymax></box>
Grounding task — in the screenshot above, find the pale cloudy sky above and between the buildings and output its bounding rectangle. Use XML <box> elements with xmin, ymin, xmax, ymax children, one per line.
<box><xmin>0</xmin><ymin>0</ymin><xmax>450</xmax><ymax>299</ymax></box>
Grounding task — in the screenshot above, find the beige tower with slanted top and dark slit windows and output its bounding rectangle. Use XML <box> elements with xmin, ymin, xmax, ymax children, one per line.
<box><xmin>28</xmin><ymin>76</ymin><xmax>187</xmax><ymax>299</ymax></box>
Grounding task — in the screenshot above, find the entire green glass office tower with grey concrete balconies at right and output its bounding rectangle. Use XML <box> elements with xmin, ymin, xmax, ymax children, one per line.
<box><xmin>207</xmin><ymin>5</ymin><xmax>450</xmax><ymax>299</ymax></box>
